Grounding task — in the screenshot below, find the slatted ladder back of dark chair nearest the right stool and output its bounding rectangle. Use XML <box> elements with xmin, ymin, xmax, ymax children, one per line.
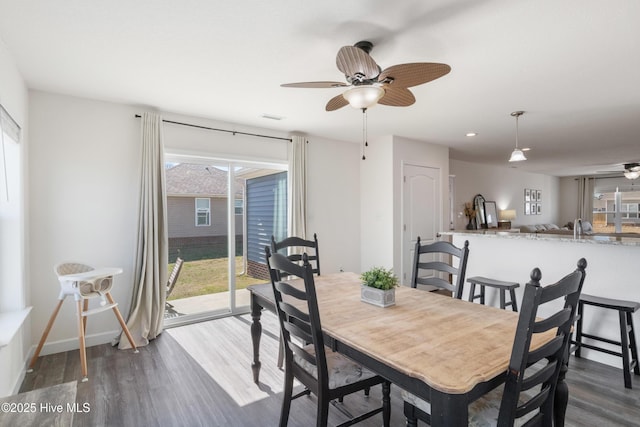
<box><xmin>498</xmin><ymin>258</ymin><xmax>587</xmax><ymax>426</ymax></box>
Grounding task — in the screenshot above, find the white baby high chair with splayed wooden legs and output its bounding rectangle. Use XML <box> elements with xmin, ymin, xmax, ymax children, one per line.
<box><xmin>29</xmin><ymin>262</ymin><xmax>138</xmax><ymax>381</ymax></box>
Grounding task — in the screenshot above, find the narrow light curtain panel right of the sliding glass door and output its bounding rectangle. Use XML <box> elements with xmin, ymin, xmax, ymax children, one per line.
<box><xmin>287</xmin><ymin>136</ymin><xmax>307</xmax><ymax>239</ymax></box>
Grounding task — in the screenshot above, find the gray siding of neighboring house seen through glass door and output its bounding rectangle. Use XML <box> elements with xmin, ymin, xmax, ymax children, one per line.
<box><xmin>167</xmin><ymin>196</ymin><xmax>243</xmax><ymax>239</ymax></box>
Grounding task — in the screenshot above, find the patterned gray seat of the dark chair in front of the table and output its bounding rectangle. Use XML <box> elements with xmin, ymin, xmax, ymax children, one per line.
<box><xmin>293</xmin><ymin>344</ymin><xmax>376</xmax><ymax>389</ymax></box>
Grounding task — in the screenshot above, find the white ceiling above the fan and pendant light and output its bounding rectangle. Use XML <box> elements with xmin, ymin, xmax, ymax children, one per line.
<box><xmin>0</xmin><ymin>0</ymin><xmax>640</xmax><ymax>176</ymax></box>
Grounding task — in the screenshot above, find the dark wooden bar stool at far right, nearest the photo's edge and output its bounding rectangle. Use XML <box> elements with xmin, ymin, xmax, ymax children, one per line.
<box><xmin>574</xmin><ymin>294</ymin><xmax>640</xmax><ymax>388</ymax></box>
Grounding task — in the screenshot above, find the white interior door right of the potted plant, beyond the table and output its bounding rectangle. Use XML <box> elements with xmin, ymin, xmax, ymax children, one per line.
<box><xmin>400</xmin><ymin>164</ymin><xmax>442</xmax><ymax>285</ymax></box>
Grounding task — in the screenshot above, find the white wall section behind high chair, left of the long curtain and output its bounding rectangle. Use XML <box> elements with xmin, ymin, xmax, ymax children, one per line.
<box><xmin>29</xmin><ymin>91</ymin><xmax>140</xmax><ymax>354</ymax></box>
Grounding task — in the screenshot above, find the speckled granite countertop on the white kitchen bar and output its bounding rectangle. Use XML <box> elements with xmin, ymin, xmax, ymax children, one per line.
<box><xmin>439</xmin><ymin>229</ymin><xmax>640</xmax><ymax>246</ymax></box>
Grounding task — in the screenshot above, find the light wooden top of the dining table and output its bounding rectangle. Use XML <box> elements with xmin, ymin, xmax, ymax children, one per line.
<box><xmin>282</xmin><ymin>273</ymin><xmax>553</xmax><ymax>394</ymax></box>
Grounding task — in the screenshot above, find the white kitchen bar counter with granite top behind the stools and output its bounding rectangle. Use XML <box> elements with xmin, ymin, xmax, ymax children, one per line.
<box><xmin>440</xmin><ymin>230</ymin><xmax>640</xmax><ymax>375</ymax></box>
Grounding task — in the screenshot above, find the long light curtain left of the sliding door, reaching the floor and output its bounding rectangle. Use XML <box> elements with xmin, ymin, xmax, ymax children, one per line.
<box><xmin>119</xmin><ymin>113</ymin><xmax>169</xmax><ymax>349</ymax></box>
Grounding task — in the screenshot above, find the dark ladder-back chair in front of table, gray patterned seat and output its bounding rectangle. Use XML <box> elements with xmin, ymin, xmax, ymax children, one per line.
<box><xmin>265</xmin><ymin>247</ymin><xmax>391</xmax><ymax>427</ymax></box>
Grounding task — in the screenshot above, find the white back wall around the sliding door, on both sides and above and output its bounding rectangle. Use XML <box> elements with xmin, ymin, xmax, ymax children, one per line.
<box><xmin>29</xmin><ymin>91</ymin><xmax>360</xmax><ymax>362</ymax></box>
